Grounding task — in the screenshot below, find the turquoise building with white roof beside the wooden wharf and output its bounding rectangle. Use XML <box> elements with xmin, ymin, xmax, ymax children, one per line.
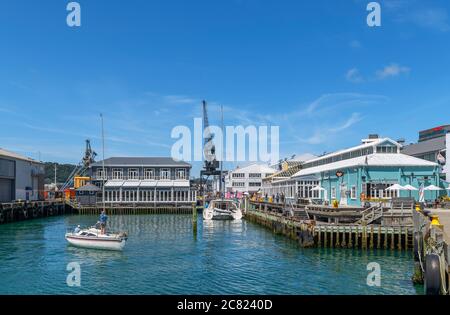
<box><xmin>289</xmin><ymin>135</ymin><xmax>441</xmax><ymax>206</ymax></box>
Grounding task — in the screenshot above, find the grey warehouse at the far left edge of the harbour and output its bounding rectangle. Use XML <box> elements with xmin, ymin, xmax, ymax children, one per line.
<box><xmin>0</xmin><ymin>148</ymin><xmax>45</xmax><ymax>202</ymax></box>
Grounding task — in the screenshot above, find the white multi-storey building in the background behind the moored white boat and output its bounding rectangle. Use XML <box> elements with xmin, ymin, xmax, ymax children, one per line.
<box><xmin>225</xmin><ymin>164</ymin><xmax>276</xmax><ymax>193</ymax></box>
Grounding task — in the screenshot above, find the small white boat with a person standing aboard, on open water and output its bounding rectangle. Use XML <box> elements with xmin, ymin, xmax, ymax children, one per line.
<box><xmin>66</xmin><ymin>227</ymin><xmax>128</xmax><ymax>250</ymax></box>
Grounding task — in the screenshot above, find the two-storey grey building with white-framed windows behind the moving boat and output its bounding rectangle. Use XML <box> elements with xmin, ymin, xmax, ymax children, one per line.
<box><xmin>89</xmin><ymin>157</ymin><xmax>197</xmax><ymax>204</ymax></box>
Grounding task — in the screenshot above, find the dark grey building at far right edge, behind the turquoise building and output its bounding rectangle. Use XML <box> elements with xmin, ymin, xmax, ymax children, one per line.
<box><xmin>402</xmin><ymin>125</ymin><xmax>450</xmax><ymax>182</ymax></box>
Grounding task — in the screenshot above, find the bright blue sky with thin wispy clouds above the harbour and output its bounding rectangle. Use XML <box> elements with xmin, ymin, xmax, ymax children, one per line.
<box><xmin>0</xmin><ymin>0</ymin><xmax>450</xmax><ymax>178</ymax></box>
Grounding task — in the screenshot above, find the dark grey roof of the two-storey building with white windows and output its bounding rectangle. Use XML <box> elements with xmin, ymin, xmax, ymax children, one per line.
<box><xmin>92</xmin><ymin>157</ymin><xmax>191</xmax><ymax>167</ymax></box>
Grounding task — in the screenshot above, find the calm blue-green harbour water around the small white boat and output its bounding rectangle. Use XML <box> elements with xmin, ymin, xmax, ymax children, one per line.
<box><xmin>0</xmin><ymin>215</ymin><xmax>422</xmax><ymax>294</ymax></box>
